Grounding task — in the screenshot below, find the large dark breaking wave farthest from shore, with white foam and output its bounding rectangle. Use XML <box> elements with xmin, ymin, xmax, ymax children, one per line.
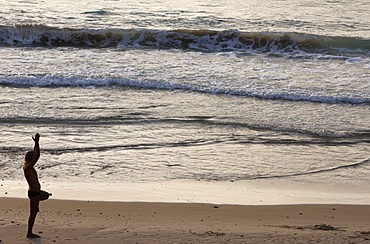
<box><xmin>0</xmin><ymin>25</ymin><xmax>370</xmax><ymax>56</ymax></box>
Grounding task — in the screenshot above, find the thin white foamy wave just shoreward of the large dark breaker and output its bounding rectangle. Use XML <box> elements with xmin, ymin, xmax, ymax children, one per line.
<box><xmin>0</xmin><ymin>75</ymin><xmax>370</xmax><ymax>104</ymax></box>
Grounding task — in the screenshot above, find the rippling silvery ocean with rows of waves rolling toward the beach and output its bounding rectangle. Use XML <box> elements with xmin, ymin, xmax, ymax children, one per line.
<box><xmin>0</xmin><ymin>0</ymin><xmax>370</xmax><ymax>202</ymax></box>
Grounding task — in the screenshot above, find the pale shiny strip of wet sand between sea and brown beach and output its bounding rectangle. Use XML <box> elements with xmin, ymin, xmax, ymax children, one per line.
<box><xmin>0</xmin><ymin>179</ymin><xmax>370</xmax><ymax>205</ymax></box>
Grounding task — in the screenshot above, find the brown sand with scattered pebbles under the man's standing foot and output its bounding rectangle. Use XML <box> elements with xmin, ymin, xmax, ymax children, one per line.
<box><xmin>0</xmin><ymin>197</ymin><xmax>370</xmax><ymax>244</ymax></box>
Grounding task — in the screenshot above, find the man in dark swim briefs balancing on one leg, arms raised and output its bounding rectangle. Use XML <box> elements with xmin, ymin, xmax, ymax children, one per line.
<box><xmin>23</xmin><ymin>133</ymin><xmax>49</xmax><ymax>238</ymax></box>
